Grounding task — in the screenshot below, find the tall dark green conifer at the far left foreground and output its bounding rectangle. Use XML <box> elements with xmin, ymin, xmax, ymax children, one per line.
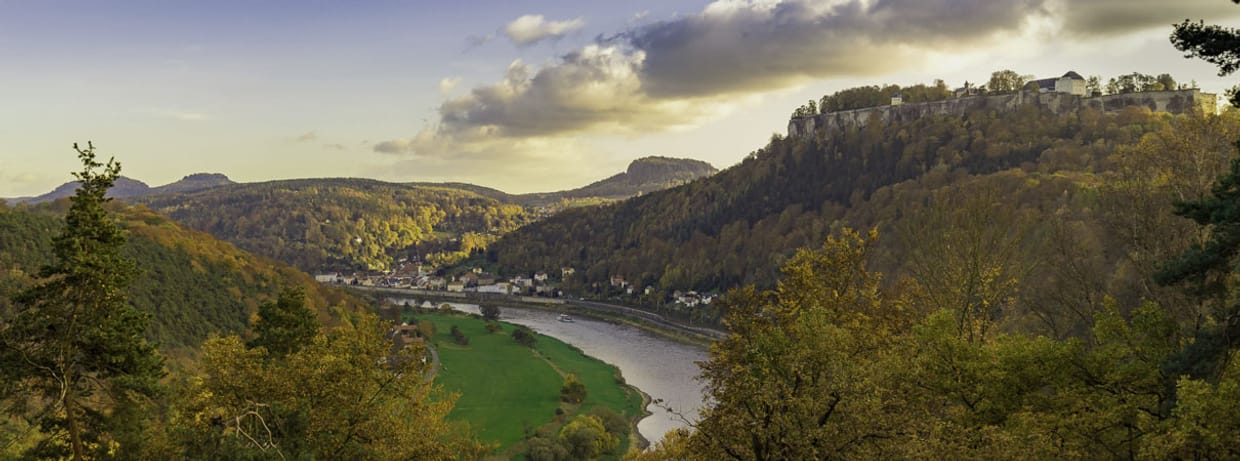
<box><xmin>0</xmin><ymin>143</ymin><xmax>164</xmax><ymax>460</ymax></box>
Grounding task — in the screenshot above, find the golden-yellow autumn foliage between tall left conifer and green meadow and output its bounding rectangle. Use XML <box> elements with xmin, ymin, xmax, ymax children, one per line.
<box><xmin>172</xmin><ymin>314</ymin><xmax>482</xmax><ymax>460</ymax></box>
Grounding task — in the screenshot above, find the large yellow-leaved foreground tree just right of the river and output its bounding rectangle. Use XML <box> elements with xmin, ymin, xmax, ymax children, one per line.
<box><xmin>691</xmin><ymin>229</ymin><xmax>910</xmax><ymax>460</ymax></box>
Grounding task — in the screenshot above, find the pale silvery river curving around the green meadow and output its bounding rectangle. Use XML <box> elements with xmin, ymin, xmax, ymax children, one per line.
<box><xmin>391</xmin><ymin>297</ymin><xmax>706</xmax><ymax>444</ymax></box>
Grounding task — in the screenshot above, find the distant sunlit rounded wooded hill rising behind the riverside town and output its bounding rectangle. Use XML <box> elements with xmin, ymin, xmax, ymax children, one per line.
<box><xmin>136</xmin><ymin>178</ymin><xmax>528</xmax><ymax>271</ymax></box>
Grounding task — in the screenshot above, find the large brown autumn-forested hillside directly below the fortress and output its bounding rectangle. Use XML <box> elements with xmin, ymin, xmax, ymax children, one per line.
<box><xmin>489</xmin><ymin>107</ymin><xmax>1236</xmax><ymax>319</ymax></box>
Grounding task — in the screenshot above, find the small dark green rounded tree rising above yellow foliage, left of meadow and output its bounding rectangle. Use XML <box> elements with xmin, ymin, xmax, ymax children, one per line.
<box><xmin>248</xmin><ymin>288</ymin><xmax>319</xmax><ymax>357</ymax></box>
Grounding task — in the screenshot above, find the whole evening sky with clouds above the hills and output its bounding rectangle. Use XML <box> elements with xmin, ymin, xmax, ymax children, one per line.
<box><xmin>0</xmin><ymin>0</ymin><xmax>1240</xmax><ymax>197</ymax></box>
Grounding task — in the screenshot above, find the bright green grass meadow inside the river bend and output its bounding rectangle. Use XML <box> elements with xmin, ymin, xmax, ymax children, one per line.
<box><xmin>418</xmin><ymin>314</ymin><xmax>642</xmax><ymax>454</ymax></box>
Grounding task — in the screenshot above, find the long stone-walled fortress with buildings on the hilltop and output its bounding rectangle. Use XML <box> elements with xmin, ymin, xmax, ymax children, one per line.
<box><xmin>787</xmin><ymin>72</ymin><xmax>1218</xmax><ymax>138</ymax></box>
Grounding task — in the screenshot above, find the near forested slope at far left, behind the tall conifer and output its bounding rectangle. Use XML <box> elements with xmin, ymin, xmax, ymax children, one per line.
<box><xmin>0</xmin><ymin>200</ymin><xmax>365</xmax><ymax>351</ymax></box>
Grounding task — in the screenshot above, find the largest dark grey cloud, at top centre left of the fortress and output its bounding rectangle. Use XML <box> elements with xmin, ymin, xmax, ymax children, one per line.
<box><xmin>629</xmin><ymin>0</ymin><xmax>1045</xmax><ymax>97</ymax></box>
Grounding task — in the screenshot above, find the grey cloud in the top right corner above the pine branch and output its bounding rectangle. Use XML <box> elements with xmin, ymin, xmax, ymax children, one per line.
<box><xmin>1053</xmin><ymin>0</ymin><xmax>1240</xmax><ymax>37</ymax></box>
